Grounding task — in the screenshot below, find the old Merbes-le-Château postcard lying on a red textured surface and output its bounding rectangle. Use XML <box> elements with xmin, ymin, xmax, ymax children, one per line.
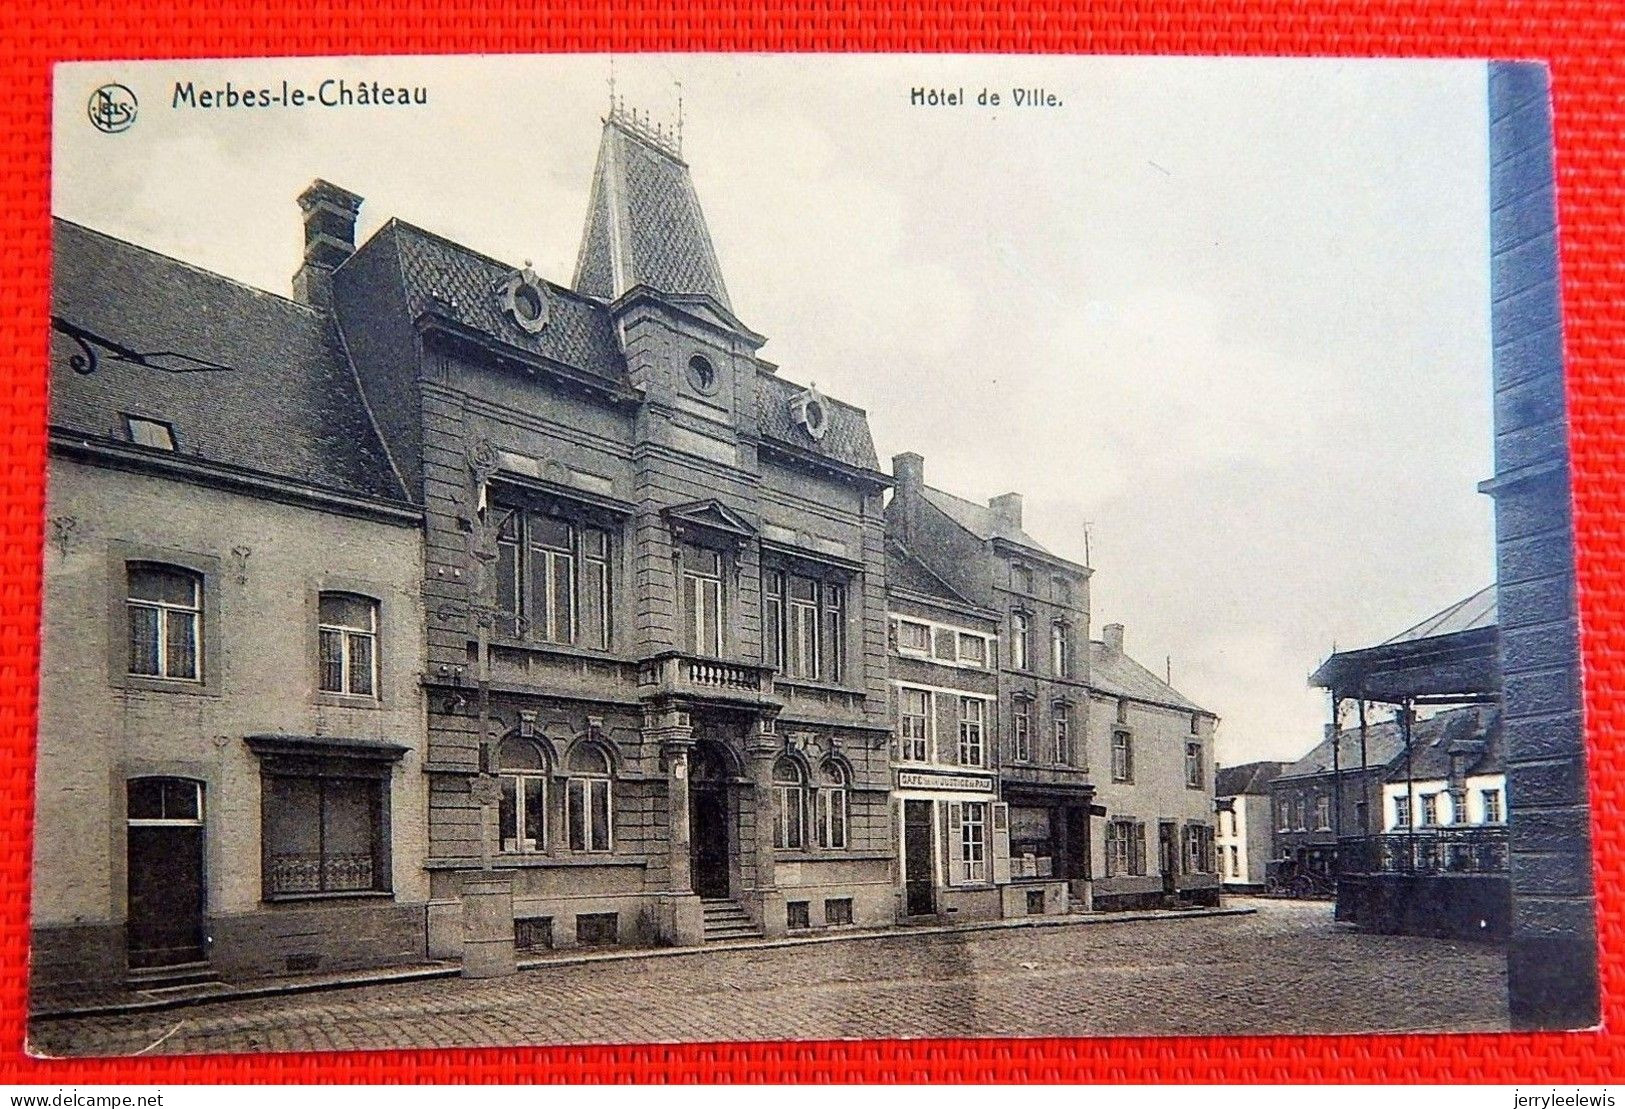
<box><xmin>31</xmin><ymin>55</ymin><xmax>1597</xmax><ymax>1055</ymax></box>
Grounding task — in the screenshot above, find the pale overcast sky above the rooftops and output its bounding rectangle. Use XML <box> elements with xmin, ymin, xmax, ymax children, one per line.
<box><xmin>54</xmin><ymin>55</ymin><xmax>1493</xmax><ymax>764</ymax></box>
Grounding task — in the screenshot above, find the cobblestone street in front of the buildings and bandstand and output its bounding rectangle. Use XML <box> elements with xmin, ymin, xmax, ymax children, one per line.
<box><xmin>31</xmin><ymin>899</ymin><xmax>1506</xmax><ymax>1055</ymax></box>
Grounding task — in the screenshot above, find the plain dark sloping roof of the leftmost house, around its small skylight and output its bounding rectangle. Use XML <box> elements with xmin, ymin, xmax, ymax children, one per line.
<box><xmin>50</xmin><ymin>220</ymin><xmax>406</xmax><ymax>501</ymax></box>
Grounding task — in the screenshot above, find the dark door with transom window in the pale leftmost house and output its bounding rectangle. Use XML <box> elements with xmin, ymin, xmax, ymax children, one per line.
<box><xmin>125</xmin><ymin>777</ymin><xmax>203</xmax><ymax>971</ymax></box>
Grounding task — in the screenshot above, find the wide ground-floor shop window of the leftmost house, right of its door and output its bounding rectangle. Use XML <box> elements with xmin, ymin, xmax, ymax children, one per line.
<box><xmin>263</xmin><ymin>776</ymin><xmax>390</xmax><ymax>896</ymax></box>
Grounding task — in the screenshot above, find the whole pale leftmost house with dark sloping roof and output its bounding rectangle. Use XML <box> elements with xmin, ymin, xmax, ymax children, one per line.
<box><xmin>45</xmin><ymin>220</ymin><xmax>429</xmax><ymax>995</ymax></box>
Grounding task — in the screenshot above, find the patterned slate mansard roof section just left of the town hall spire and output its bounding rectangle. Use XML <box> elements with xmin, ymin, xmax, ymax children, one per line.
<box><xmin>380</xmin><ymin>220</ymin><xmax>626</xmax><ymax>384</ymax></box>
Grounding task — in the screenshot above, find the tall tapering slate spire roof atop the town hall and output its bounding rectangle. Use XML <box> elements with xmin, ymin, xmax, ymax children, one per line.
<box><xmin>572</xmin><ymin>109</ymin><xmax>733</xmax><ymax>314</ymax></box>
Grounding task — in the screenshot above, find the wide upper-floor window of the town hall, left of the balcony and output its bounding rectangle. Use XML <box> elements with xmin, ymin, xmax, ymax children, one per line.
<box><xmin>492</xmin><ymin>506</ymin><xmax>609</xmax><ymax>650</ymax></box>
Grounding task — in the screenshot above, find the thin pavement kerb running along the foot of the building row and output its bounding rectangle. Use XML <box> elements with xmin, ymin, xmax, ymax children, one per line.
<box><xmin>28</xmin><ymin>907</ymin><xmax>1258</xmax><ymax>1020</ymax></box>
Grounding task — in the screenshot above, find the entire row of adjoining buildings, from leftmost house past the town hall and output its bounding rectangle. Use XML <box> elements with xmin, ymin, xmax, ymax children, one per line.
<box><xmin>34</xmin><ymin>101</ymin><xmax>1217</xmax><ymax>989</ymax></box>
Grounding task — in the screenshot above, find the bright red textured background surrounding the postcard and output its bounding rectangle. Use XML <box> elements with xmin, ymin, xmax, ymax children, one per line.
<box><xmin>0</xmin><ymin>0</ymin><xmax>1625</xmax><ymax>1083</ymax></box>
